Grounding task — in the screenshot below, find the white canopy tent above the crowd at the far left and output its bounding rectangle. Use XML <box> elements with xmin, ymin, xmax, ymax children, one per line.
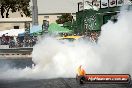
<box><xmin>0</xmin><ymin>29</ymin><xmax>25</xmax><ymax>37</ymax></box>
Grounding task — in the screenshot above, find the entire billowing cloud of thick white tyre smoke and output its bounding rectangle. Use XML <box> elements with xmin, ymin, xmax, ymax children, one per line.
<box><xmin>0</xmin><ymin>5</ymin><xmax>132</xmax><ymax>79</ymax></box>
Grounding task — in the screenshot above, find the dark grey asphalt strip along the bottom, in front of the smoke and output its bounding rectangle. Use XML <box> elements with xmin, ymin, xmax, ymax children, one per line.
<box><xmin>0</xmin><ymin>78</ymin><xmax>132</xmax><ymax>88</ymax></box>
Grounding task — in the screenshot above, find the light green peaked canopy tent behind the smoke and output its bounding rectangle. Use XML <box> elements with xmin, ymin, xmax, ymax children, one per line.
<box><xmin>48</xmin><ymin>23</ymin><xmax>72</xmax><ymax>33</ymax></box>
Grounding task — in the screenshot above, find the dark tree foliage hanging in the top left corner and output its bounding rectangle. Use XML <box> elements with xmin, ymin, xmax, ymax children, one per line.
<box><xmin>0</xmin><ymin>0</ymin><xmax>31</xmax><ymax>18</ymax></box>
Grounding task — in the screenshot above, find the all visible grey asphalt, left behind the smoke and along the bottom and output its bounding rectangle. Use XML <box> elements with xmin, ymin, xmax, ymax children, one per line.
<box><xmin>0</xmin><ymin>59</ymin><xmax>132</xmax><ymax>88</ymax></box>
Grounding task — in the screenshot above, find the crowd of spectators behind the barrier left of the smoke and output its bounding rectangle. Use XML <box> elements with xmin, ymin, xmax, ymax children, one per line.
<box><xmin>0</xmin><ymin>35</ymin><xmax>37</xmax><ymax>48</ymax></box>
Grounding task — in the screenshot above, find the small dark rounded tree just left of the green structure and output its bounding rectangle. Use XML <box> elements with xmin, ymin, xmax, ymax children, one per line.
<box><xmin>56</xmin><ymin>13</ymin><xmax>73</xmax><ymax>24</ymax></box>
